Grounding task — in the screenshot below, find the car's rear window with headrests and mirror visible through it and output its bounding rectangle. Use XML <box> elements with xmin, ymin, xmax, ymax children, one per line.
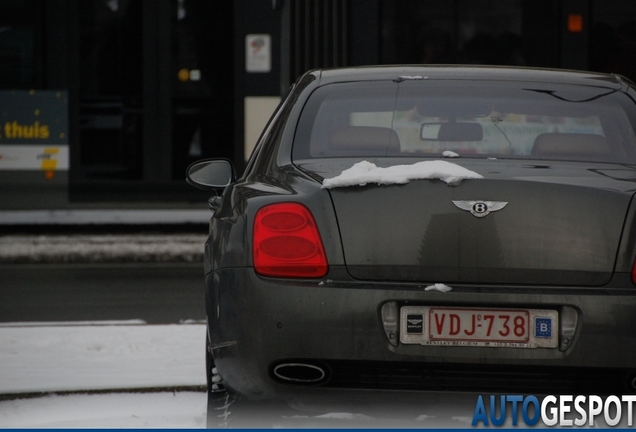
<box><xmin>293</xmin><ymin>79</ymin><xmax>636</xmax><ymax>163</ymax></box>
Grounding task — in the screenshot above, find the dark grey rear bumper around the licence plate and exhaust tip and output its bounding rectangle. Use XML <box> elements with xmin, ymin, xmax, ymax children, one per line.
<box><xmin>206</xmin><ymin>268</ymin><xmax>636</xmax><ymax>401</ymax></box>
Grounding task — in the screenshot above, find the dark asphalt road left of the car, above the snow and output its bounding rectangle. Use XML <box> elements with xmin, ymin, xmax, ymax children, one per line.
<box><xmin>0</xmin><ymin>263</ymin><xmax>205</xmax><ymax>324</ymax></box>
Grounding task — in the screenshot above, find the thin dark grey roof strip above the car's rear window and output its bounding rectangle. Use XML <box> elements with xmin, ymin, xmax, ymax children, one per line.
<box><xmin>311</xmin><ymin>65</ymin><xmax>626</xmax><ymax>89</ymax></box>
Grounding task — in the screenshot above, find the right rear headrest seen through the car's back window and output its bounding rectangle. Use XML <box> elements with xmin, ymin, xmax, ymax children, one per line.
<box><xmin>532</xmin><ymin>133</ymin><xmax>609</xmax><ymax>157</ymax></box>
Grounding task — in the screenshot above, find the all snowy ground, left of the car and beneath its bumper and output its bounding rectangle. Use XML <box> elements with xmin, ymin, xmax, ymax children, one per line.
<box><xmin>0</xmin><ymin>321</ymin><xmax>540</xmax><ymax>429</ymax></box>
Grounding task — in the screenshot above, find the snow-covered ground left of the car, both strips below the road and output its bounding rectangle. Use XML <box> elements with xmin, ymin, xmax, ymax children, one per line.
<box><xmin>0</xmin><ymin>321</ymin><xmax>206</xmax><ymax>428</ymax></box>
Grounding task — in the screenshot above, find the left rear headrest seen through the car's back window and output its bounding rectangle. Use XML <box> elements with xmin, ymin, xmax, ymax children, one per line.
<box><xmin>329</xmin><ymin>126</ymin><xmax>400</xmax><ymax>152</ymax></box>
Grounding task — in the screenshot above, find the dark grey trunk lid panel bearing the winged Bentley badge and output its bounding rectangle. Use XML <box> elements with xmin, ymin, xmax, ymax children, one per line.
<box><xmin>322</xmin><ymin>160</ymin><xmax>631</xmax><ymax>286</ymax></box>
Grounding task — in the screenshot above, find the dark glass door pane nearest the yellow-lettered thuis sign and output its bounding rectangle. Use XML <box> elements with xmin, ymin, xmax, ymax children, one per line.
<box><xmin>79</xmin><ymin>0</ymin><xmax>142</xmax><ymax>179</ymax></box>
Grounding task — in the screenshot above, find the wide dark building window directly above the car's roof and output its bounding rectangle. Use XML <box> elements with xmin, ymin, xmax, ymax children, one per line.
<box><xmin>380</xmin><ymin>0</ymin><xmax>560</xmax><ymax>67</ymax></box>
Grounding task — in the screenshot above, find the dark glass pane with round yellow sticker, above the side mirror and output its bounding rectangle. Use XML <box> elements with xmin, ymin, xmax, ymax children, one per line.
<box><xmin>172</xmin><ymin>0</ymin><xmax>233</xmax><ymax>180</ymax></box>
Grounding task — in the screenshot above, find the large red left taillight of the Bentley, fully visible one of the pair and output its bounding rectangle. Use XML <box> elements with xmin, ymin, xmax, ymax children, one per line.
<box><xmin>253</xmin><ymin>203</ymin><xmax>328</xmax><ymax>278</ymax></box>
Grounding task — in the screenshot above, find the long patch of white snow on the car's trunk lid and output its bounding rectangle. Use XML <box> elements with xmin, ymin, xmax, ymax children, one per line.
<box><xmin>322</xmin><ymin>161</ymin><xmax>483</xmax><ymax>189</ymax></box>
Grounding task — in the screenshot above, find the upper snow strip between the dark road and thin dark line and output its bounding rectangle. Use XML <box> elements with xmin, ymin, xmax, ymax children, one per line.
<box><xmin>0</xmin><ymin>324</ymin><xmax>206</xmax><ymax>394</ymax></box>
